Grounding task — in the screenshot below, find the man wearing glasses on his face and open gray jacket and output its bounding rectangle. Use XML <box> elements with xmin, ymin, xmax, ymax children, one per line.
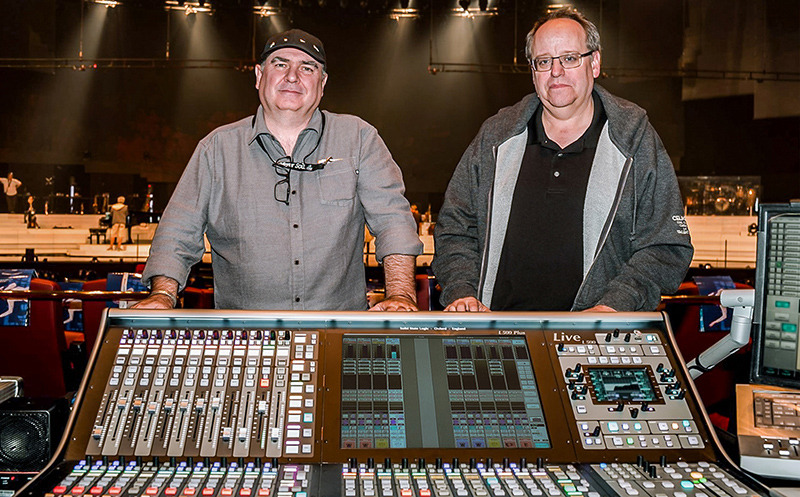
<box><xmin>433</xmin><ymin>8</ymin><xmax>693</xmax><ymax>311</ymax></box>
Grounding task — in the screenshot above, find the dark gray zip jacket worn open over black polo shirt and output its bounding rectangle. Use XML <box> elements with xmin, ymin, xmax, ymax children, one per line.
<box><xmin>432</xmin><ymin>85</ymin><xmax>694</xmax><ymax>311</ymax></box>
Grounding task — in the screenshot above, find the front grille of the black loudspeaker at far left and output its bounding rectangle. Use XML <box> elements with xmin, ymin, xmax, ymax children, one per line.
<box><xmin>0</xmin><ymin>412</ymin><xmax>51</xmax><ymax>471</ymax></box>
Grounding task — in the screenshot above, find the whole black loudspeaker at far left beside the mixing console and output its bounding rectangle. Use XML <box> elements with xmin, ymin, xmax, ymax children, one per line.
<box><xmin>0</xmin><ymin>397</ymin><xmax>69</xmax><ymax>473</ymax></box>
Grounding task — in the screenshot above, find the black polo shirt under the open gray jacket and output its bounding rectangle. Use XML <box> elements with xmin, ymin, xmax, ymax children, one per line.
<box><xmin>491</xmin><ymin>92</ymin><xmax>606</xmax><ymax>311</ymax></box>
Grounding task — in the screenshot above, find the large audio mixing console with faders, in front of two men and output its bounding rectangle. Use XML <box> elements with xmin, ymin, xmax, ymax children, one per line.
<box><xmin>19</xmin><ymin>310</ymin><xmax>769</xmax><ymax>497</ymax></box>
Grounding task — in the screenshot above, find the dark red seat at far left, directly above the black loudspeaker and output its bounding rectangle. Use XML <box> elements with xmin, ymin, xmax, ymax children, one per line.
<box><xmin>0</xmin><ymin>278</ymin><xmax>67</xmax><ymax>397</ymax></box>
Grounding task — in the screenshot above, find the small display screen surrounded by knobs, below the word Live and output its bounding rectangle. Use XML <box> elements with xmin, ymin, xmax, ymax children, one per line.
<box><xmin>588</xmin><ymin>367</ymin><xmax>659</xmax><ymax>402</ymax></box>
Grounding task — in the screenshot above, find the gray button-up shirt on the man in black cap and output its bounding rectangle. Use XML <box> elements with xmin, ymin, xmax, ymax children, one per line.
<box><xmin>143</xmin><ymin>107</ymin><xmax>422</xmax><ymax>310</ymax></box>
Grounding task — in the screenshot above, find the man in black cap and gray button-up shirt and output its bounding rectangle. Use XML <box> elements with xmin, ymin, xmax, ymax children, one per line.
<box><xmin>137</xmin><ymin>29</ymin><xmax>422</xmax><ymax>311</ymax></box>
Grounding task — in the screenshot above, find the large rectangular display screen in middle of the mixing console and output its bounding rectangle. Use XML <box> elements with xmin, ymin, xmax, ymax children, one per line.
<box><xmin>341</xmin><ymin>335</ymin><xmax>551</xmax><ymax>449</ymax></box>
